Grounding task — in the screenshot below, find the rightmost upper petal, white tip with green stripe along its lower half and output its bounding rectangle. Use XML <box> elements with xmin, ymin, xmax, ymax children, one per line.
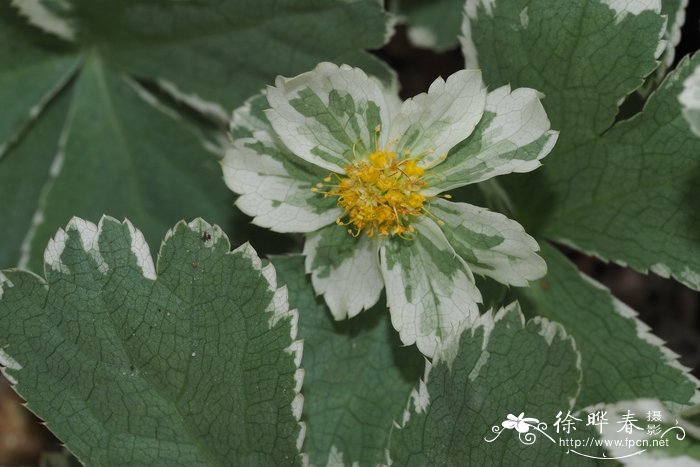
<box><xmin>425</xmin><ymin>86</ymin><xmax>559</xmax><ymax>194</ymax></box>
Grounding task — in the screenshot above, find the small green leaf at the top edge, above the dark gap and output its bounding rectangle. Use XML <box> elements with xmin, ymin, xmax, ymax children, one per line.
<box><xmin>395</xmin><ymin>0</ymin><xmax>464</xmax><ymax>52</ymax></box>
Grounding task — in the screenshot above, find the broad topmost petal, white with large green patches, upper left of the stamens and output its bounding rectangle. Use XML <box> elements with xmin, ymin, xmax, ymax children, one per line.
<box><xmin>267</xmin><ymin>63</ymin><xmax>389</xmax><ymax>173</ymax></box>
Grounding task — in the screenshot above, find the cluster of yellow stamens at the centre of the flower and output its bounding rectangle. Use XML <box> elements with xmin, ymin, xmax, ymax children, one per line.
<box><xmin>312</xmin><ymin>150</ymin><xmax>427</xmax><ymax>237</ymax></box>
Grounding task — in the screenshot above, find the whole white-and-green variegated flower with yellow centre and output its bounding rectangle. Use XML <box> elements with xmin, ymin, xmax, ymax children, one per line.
<box><xmin>223</xmin><ymin>63</ymin><xmax>557</xmax><ymax>357</ymax></box>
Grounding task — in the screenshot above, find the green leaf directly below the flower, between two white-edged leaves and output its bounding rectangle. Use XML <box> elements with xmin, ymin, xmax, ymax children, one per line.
<box><xmin>272</xmin><ymin>256</ymin><xmax>423</xmax><ymax>465</ymax></box>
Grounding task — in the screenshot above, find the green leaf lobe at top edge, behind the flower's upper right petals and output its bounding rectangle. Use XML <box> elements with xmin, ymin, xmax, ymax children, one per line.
<box><xmin>462</xmin><ymin>0</ymin><xmax>664</xmax><ymax>148</ymax></box>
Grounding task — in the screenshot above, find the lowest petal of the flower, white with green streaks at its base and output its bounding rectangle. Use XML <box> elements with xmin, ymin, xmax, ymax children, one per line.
<box><xmin>380</xmin><ymin>218</ymin><xmax>481</xmax><ymax>361</ymax></box>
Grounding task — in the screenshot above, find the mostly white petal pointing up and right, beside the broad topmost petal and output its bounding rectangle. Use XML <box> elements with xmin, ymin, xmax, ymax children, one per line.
<box><xmin>389</xmin><ymin>70</ymin><xmax>486</xmax><ymax>167</ymax></box>
